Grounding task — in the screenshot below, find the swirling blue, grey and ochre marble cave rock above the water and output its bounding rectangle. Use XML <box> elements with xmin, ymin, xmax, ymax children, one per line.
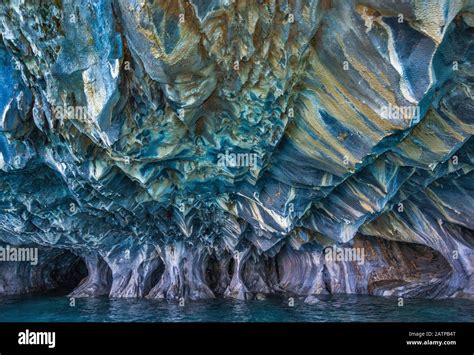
<box><xmin>0</xmin><ymin>0</ymin><xmax>474</xmax><ymax>303</ymax></box>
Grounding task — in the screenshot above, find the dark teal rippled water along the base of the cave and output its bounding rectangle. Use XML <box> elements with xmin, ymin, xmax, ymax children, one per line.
<box><xmin>0</xmin><ymin>296</ymin><xmax>474</xmax><ymax>322</ymax></box>
